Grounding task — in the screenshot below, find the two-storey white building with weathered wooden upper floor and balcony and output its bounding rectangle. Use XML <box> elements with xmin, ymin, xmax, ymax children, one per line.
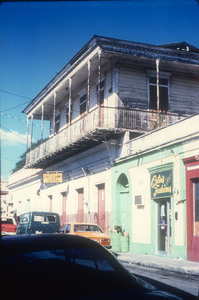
<box><xmin>9</xmin><ymin>36</ymin><xmax>199</xmax><ymax>248</ymax></box>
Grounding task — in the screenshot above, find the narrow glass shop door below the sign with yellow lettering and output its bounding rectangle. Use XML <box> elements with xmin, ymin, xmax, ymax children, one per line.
<box><xmin>157</xmin><ymin>198</ymin><xmax>172</xmax><ymax>255</ymax></box>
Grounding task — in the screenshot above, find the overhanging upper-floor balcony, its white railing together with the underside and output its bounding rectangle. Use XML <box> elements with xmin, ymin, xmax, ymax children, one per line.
<box><xmin>26</xmin><ymin>107</ymin><xmax>187</xmax><ymax>168</ymax></box>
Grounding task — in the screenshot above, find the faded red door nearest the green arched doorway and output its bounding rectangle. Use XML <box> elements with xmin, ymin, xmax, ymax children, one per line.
<box><xmin>97</xmin><ymin>183</ymin><xmax>105</xmax><ymax>231</ymax></box>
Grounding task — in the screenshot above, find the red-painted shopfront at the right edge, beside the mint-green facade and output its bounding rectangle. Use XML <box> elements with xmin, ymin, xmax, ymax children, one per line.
<box><xmin>184</xmin><ymin>160</ymin><xmax>199</xmax><ymax>261</ymax></box>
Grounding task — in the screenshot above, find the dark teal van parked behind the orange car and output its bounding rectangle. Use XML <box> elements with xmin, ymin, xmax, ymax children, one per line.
<box><xmin>17</xmin><ymin>211</ymin><xmax>60</xmax><ymax>235</ymax></box>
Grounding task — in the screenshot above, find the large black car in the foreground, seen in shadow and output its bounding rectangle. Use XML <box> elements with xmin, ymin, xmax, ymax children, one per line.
<box><xmin>1</xmin><ymin>234</ymin><xmax>193</xmax><ymax>300</ymax></box>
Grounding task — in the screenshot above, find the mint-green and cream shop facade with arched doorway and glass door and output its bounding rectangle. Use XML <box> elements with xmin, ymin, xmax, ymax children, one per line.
<box><xmin>111</xmin><ymin>142</ymin><xmax>187</xmax><ymax>259</ymax></box>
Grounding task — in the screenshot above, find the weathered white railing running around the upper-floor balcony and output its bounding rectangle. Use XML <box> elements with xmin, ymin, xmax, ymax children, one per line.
<box><xmin>26</xmin><ymin>107</ymin><xmax>185</xmax><ymax>167</ymax></box>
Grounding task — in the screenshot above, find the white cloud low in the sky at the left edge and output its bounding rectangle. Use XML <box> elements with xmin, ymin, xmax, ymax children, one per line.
<box><xmin>0</xmin><ymin>129</ymin><xmax>30</xmax><ymax>146</ymax></box>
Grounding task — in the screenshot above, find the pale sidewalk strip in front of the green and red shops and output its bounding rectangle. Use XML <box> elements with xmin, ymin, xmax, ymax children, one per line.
<box><xmin>117</xmin><ymin>252</ymin><xmax>199</xmax><ymax>275</ymax></box>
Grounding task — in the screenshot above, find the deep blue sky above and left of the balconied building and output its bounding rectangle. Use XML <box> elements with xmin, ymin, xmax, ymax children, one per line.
<box><xmin>0</xmin><ymin>0</ymin><xmax>199</xmax><ymax>180</ymax></box>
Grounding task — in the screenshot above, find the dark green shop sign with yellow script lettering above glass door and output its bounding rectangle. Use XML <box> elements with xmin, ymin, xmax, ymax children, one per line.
<box><xmin>151</xmin><ymin>170</ymin><xmax>173</xmax><ymax>199</ymax></box>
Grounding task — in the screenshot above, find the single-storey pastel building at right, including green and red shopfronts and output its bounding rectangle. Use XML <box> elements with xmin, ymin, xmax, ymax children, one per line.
<box><xmin>111</xmin><ymin>115</ymin><xmax>199</xmax><ymax>261</ymax></box>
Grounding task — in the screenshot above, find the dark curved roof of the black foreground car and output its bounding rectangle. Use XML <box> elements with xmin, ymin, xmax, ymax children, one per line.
<box><xmin>1</xmin><ymin>233</ymin><xmax>100</xmax><ymax>255</ymax></box>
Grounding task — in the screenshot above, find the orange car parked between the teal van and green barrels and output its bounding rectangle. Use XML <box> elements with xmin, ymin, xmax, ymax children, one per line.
<box><xmin>60</xmin><ymin>222</ymin><xmax>111</xmax><ymax>249</ymax></box>
